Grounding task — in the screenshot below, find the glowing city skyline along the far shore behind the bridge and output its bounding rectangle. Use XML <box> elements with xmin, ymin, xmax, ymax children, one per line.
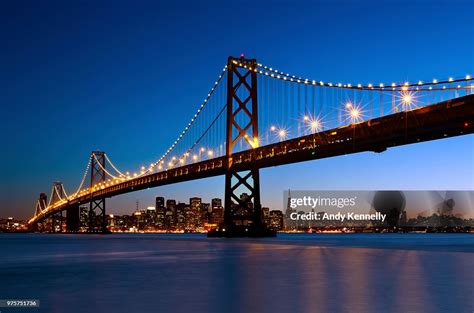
<box><xmin>4</xmin><ymin>191</ymin><xmax>474</xmax><ymax>233</ymax></box>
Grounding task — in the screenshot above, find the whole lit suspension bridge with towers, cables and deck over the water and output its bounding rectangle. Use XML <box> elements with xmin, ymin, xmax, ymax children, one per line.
<box><xmin>29</xmin><ymin>56</ymin><xmax>474</xmax><ymax>235</ymax></box>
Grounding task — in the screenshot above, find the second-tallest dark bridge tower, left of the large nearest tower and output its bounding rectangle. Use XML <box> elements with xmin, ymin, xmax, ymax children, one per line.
<box><xmin>88</xmin><ymin>151</ymin><xmax>107</xmax><ymax>233</ymax></box>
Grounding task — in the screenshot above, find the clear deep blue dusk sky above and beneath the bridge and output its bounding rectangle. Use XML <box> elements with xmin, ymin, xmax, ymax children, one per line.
<box><xmin>0</xmin><ymin>0</ymin><xmax>474</xmax><ymax>218</ymax></box>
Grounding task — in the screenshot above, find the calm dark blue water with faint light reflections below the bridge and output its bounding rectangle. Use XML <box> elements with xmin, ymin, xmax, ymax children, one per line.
<box><xmin>0</xmin><ymin>234</ymin><xmax>474</xmax><ymax>313</ymax></box>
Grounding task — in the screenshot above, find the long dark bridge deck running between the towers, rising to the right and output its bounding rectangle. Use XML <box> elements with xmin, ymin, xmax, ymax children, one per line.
<box><xmin>30</xmin><ymin>95</ymin><xmax>474</xmax><ymax>223</ymax></box>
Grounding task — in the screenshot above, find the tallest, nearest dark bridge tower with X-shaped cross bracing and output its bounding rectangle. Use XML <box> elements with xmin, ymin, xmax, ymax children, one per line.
<box><xmin>223</xmin><ymin>57</ymin><xmax>272</xmax><ymax>236</ymax></box>
